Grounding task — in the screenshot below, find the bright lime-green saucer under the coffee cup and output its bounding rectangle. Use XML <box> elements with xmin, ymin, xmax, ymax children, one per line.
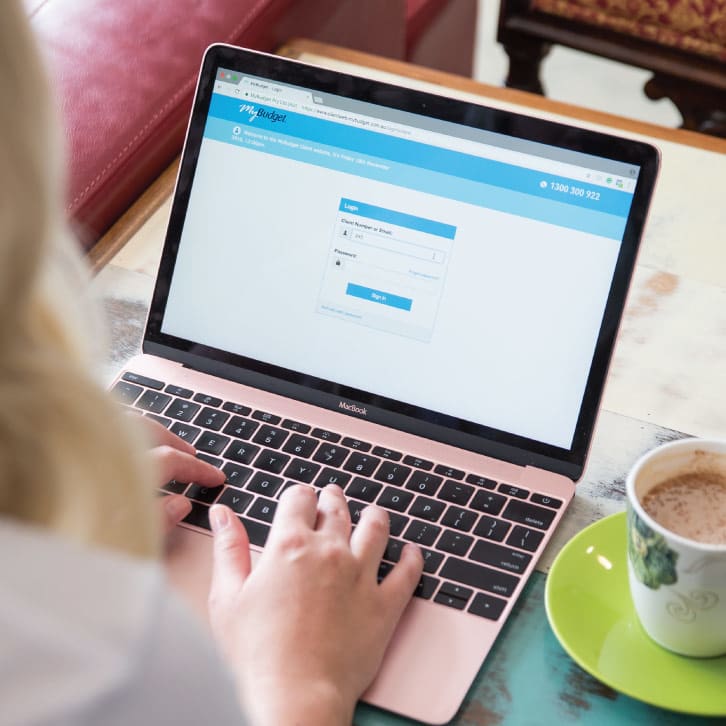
<box><xmin>545</xmin><ymin>512</ymin><xmax>726</xmax><ymax>716</ymax></box>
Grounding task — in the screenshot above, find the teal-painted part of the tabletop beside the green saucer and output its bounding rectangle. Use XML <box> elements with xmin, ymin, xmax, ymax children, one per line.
<box><xmin>355</xmin><ymin>572</ymin><xmax>726</xmax><ymax>726</ymax></box>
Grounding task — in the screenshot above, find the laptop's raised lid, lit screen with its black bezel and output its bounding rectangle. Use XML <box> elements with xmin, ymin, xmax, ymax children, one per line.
<box><xmin>143</xmin><ymin>45</ymin><xmax>659</xmax><ymax>480</ymax></box>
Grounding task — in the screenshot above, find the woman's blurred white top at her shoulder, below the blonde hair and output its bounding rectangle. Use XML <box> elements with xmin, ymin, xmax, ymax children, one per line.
<box><xmin>0</xmin><ymin>517</ymin><xmax>244</xmax><ymax>726</ymax></box>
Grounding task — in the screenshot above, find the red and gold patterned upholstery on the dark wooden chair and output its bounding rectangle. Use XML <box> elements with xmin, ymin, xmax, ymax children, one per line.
<box><xmin>532</xmin><ymin>0</ymin><xmax>726</xmax><ymax>61</ymax></box>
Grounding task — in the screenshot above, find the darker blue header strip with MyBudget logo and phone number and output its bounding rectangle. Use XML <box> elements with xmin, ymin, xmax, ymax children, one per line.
<box><xmin>209</xmin><ymin>93</ymin><xmax>632</xmax><ymax>217</ymax></box>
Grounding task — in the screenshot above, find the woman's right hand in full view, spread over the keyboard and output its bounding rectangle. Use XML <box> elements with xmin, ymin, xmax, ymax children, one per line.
<box><xmin>209</xmin><ymin>485</ymin><xmax>423</xmax><ymax>726</ymax></box>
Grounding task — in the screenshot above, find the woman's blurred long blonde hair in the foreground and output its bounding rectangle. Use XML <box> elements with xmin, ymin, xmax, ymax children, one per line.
<box><xmin>0</xmin><ymin>0</ymin><xmax>159</xmax><ymax>556</ymax></box>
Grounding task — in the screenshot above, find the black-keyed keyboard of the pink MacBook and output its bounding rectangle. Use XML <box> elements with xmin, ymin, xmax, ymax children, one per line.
<box><xmin>113</xmin><ymin>372</ymin><xmax>562</xmax><ymax>620</ymax></box>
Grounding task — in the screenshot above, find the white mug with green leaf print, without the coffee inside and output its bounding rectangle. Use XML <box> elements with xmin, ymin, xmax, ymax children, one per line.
<box><xmin>626</xmin><ymin>439</ymin><xmax>726</xmax><ymax>657</ymax></box>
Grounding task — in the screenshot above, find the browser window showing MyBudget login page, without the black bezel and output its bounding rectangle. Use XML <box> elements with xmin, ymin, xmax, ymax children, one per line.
<box><xmin>162</xmin><ymin>69</ymin><xmax>638</xmax><ymax>448</ymax></box>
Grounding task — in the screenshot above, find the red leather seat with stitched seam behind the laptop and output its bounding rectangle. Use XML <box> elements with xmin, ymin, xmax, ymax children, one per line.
<box><xmin>26</xmin><ymin>0</ymin><xmax>476</xmax><ymax>248</ymax></box>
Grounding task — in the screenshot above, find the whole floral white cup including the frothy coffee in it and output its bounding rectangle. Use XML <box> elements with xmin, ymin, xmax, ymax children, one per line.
<box><xmin>626</xmin><ymin>439</ymin><xmax>726</xmax><ymax>657</ymax></box>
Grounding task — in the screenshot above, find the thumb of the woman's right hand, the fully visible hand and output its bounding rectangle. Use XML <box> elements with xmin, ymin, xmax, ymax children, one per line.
<box><xmin>209</xmin><ymin>504</ymin><xmax>252</xmax><ymax>609</ymax></box>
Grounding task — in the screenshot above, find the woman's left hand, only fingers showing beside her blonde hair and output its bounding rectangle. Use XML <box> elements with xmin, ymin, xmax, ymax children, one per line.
<box><xmin>138</xmin><ymin>416</ymin><xmax>225</xmax><ymax>534</ymax></box>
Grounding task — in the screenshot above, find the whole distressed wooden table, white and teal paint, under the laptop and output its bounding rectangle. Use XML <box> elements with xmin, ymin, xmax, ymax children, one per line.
<box><xmin>91</xmin><ymin>41</ymin><xmax>726</xmax><ymax>726</ymax></box>
